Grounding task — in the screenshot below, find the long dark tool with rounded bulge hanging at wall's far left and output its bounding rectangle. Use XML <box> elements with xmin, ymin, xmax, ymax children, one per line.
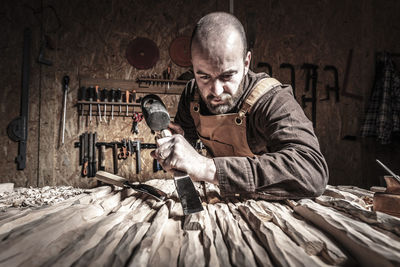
<box><xmin>7</xmin><ymin>28</ymin><xmax>32</xmax><ymax>170</ymax></box>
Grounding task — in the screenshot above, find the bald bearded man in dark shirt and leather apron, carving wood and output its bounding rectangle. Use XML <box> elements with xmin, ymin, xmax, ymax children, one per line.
<box><xmin>152</xmin><ymin>12</ymin><xmax>328</xmax><ymax>199</ymax></box>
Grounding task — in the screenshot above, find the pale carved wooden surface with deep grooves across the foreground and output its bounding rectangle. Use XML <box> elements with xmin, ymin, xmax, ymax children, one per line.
<box><xmin>0</xmin><ymin>180</ymin><xmax>400</xmax><ymax>267</ymax></box>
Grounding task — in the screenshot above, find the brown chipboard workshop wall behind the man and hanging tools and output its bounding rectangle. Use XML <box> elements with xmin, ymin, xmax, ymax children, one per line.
<box><xmin>0</xmin><ymin>0</ymin><xmax>400</xmax><ymax>187</ymax></box>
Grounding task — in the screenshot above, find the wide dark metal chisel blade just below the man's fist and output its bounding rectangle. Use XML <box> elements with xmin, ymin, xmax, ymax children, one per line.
<box><xmin>174</xmin><ymin>171</ymin><xmax>203</xmax><ymax>215</ymax></box>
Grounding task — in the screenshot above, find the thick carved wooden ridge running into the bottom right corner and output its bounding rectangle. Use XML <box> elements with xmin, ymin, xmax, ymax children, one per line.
<box><xmin>294</xmin><ymin>199</ymin><xmax>400</xmax><ymax>266</ymax></box>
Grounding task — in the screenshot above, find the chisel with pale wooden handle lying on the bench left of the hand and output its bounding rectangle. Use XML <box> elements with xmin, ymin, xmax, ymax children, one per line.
<box><xmin>96</xmin><ymin>171</ymin><xmax>167</xmax><ymax>201</ymax></box>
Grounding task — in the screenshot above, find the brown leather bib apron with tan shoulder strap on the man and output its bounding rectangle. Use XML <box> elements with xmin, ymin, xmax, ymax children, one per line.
<box><xmin>190</xmin><ymin>78</ymin><xmax>281</xmax><ymax>157</ymax></box>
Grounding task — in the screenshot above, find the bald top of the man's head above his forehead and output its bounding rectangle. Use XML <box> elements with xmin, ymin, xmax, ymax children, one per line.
<box><xmin>191</xmin><ymin>12</ymin><xmax>247</xmax><ymax>58</ymax></box>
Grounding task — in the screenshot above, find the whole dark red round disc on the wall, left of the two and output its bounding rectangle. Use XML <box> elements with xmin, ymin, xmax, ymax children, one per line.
<box><xmin>126</xmin><ymin>37</ymin><xmax>160</xmax><ymax>70</ymax></box>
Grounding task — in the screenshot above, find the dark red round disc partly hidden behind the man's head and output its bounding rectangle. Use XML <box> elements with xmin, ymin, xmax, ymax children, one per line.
<box><xmin>169</xmin><ymin>36</ymin><xmax>192</xmax><ymax>67</ymax></box>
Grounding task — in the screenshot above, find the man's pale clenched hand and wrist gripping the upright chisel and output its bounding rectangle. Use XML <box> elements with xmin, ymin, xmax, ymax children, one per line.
<box><xmin>151</xmin><ymin>134</ymin><xmax>218</xmax><ymax>184</ymax></box>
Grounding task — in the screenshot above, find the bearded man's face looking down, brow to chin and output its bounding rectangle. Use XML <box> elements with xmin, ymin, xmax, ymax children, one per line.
<box><xmin>192</xmin><ymin>35</ymin><xmax>251</xmax><ymax>114</ymax></box>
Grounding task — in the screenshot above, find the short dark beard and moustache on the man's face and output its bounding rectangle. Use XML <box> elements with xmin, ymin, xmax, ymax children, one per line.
<box><xmin>203</xmin><ymin>72</ymin><xmax>245</xmax><ymax>115</ymax></box>
